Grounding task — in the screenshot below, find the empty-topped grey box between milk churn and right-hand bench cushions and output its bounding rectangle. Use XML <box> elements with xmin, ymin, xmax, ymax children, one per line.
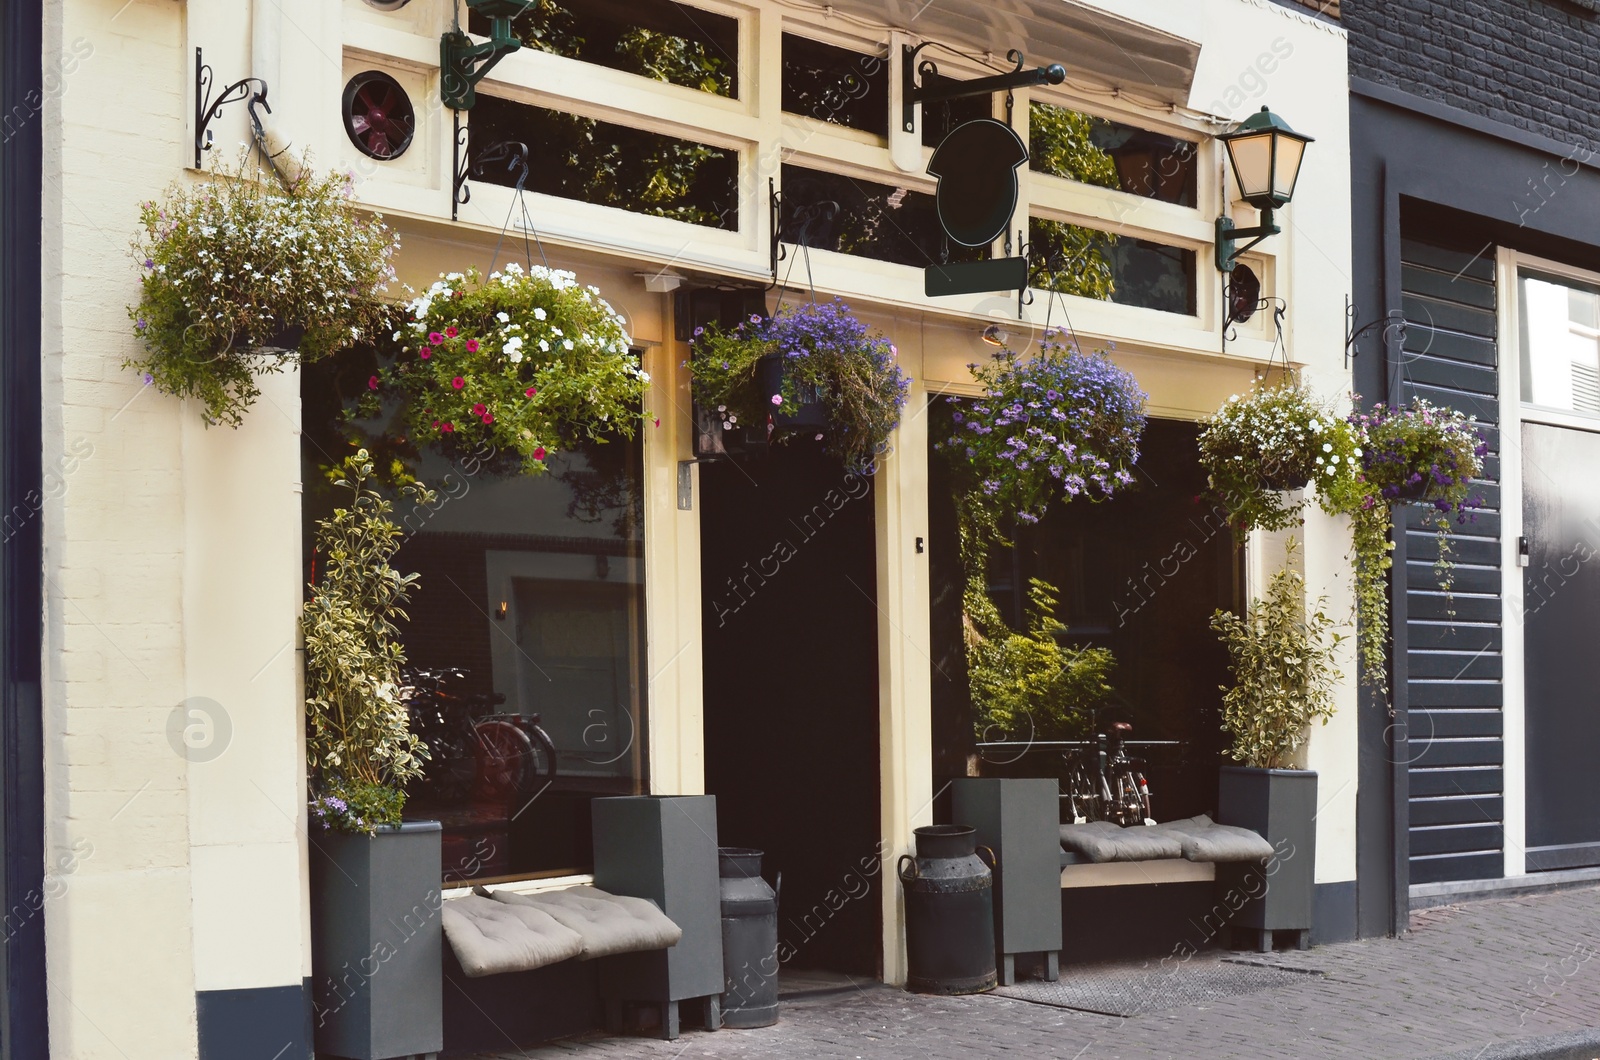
<box><xmin>950</xmin><ymin>778</ymin><xmax>1061</xmax><ymax>986</ymax></box>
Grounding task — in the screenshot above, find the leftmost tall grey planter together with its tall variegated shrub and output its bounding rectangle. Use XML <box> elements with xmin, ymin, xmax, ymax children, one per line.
<box><xmin>302</xmin><ymin>450</ymin><xmax>443</xmax><ymax>1060</ymax></box>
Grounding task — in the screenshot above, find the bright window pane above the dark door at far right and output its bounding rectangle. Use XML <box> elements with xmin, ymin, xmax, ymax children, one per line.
<box><xmin>1517</xmin><ymin>272</ymin><xmax>1600</xmax><ymax>416</ymax></box>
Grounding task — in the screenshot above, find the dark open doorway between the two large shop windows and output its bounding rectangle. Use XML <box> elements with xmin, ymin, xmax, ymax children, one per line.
<box><xmin>699</xmin><ymin>440</ymin><xmax>882</xmax><ymax>977</ymax></box>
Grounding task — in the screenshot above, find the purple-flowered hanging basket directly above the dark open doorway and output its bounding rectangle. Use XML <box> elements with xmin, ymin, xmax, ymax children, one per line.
<box><xmin>688</xmin><ymin>301</ymin><xmax>910</xmax><ymax>474</ymax></box>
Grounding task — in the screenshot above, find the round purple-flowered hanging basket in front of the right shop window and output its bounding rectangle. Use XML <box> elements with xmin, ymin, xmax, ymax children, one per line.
<box><xmin>939</xmin><ymin>330</ymin><xmax>1147</xmax><ymax>524</ymax></box>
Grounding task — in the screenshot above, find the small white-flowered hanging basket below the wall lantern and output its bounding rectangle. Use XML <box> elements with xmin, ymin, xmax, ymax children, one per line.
<box><xmin>1200</xmin><ymin>379</ymin><xmax>1362</xmax><ymax>533</ymax></box>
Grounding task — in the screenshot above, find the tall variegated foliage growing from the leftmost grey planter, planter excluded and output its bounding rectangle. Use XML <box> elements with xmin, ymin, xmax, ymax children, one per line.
<box><xmin>301</xmin><ymin>450</ymin><xmax>432</xmax><ymax>834</ymax></box>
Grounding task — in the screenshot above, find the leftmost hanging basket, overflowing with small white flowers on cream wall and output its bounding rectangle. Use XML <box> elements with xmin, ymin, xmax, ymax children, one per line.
<box><xmin>123</xmin><ymin>153</ymin><xmax>398</xmax><ymax>428</ymax></box>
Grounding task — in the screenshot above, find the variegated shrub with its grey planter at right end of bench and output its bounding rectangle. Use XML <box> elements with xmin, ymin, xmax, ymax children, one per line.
<box><xmin>1211</xmin><ymin>540</ymin><xmax>1344</xmax><ymax>946</ymax></box>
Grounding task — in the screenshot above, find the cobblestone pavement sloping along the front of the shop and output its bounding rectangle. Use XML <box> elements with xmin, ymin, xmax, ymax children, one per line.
<box><xmin>477</xmin><ymin>889</ymin><xmax>1600</xmax><ymax>1060</ymax></box>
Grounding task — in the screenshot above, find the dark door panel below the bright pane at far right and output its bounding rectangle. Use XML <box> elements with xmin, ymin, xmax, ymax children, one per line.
<box><xmin>1522</xmin><ymin>423</ymin><xmax>1600</xmax><ymax>871</ymax></box>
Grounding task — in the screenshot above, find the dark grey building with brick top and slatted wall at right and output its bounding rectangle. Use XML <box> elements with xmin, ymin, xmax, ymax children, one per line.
<box><xmin>1341</xmin><ymin>0</ymin><xmax>1600</xmax><ymax>935</ymax></box>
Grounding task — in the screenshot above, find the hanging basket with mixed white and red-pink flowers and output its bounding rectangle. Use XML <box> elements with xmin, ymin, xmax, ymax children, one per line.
<box><xmin>368</xmin><ymin>264</ymin><xmax>650</xmax><ymax>474</ymax></box>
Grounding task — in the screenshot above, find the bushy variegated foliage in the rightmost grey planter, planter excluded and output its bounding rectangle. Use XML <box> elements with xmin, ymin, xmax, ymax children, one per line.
<box><xmin>1211</xmin><ymin>540</ymin><xmax>1344</xmax><ymax>769</ymax></box>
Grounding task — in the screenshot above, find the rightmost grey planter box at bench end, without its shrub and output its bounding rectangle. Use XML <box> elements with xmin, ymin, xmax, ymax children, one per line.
<box><xmin>1216</xmin><ymin>765</ymin><xmax>1317</xmax><ymax>953</ymax></box>
